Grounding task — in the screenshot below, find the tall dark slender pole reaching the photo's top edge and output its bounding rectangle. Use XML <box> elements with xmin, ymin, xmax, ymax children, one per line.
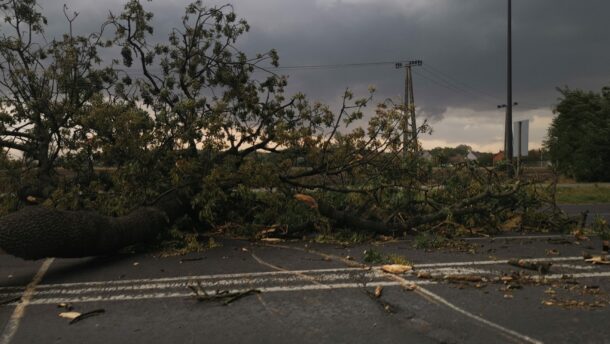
<box><xmin>504</xmin><ymin>0</ymin><xmax>514</xmax><ymax>178</ymax></box>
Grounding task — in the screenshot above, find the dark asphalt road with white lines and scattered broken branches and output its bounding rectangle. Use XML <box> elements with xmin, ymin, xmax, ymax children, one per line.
<box><xmin>0</xmin><ymin>235</ymin><xmax>610</xmax><ymax>344</ymax></box>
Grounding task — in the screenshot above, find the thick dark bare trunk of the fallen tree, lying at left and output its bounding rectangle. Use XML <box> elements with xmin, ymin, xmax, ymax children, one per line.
<box><xmin>0</xmin><ymin>191</ymin><xmax>191</xmax><ymax>260</ymax></box>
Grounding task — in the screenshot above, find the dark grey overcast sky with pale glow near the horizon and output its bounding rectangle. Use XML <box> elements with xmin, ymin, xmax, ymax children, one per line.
<box><xmin>40</xmin><ymin>0</ymin><xmax>610</xmax><ymax>151</ymax></box>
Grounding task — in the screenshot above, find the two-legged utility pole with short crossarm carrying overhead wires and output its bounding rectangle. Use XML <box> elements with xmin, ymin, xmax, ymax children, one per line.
<box><xmin>396</xmin><ymin>60</ymin><xmax>423</xmax><ymax>161</ymax></box>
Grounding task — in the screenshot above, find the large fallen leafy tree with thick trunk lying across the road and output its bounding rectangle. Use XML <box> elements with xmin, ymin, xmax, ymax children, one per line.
<box><xmin>0</xmin><ymin>0</ymin><xmax>568</xmax><ymax>259</ymax></box>
